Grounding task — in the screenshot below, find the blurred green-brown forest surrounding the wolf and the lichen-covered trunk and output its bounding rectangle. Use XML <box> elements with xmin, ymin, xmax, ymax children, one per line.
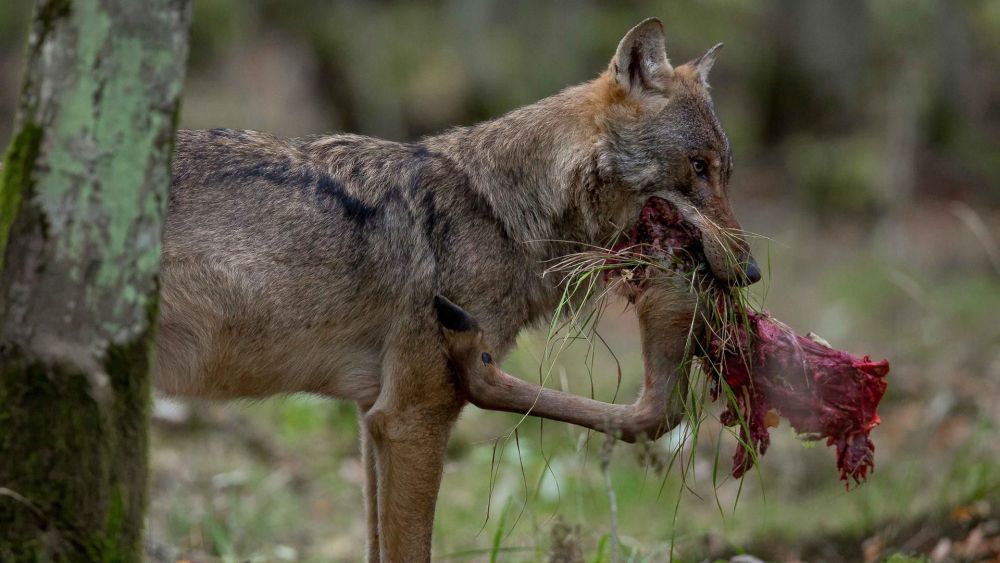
<box><xmin>0</xmin><ymin>0</ymin><xmax>1000</xmax><ymax>561</ymax></box>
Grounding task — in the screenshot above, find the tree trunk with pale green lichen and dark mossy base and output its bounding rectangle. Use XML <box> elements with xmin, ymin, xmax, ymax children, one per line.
<box><xmin>0</xmin><ymin>0</ymin><xmax>190</xmax><ymax>561</ymax></box>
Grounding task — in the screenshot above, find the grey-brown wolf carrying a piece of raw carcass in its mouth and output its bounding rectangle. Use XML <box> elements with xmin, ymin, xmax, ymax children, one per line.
<box><xmin>154</xmin><ymin>19</ymin><xmax>760</xmax><ymax>561</ymax></box>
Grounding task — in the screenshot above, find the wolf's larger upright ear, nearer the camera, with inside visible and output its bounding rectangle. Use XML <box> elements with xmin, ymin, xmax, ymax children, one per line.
<box><xmin>610</xmin><ymin>18</ymin><xmax>673</xmax><ymax>93</ymax></box>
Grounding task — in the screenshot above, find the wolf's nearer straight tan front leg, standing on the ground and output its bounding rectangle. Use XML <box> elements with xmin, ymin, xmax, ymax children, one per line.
<box><xmin>364</xmin><ymin>347</ymin><xmax>462</xmax><ymax>562</ymax></box>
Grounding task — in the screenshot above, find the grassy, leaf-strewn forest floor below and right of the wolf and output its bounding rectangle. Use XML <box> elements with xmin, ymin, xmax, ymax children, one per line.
<box><xmin>147</xmin><ymin>206</ymin><xmax>1000</xmax><ymax>562</ymax></box>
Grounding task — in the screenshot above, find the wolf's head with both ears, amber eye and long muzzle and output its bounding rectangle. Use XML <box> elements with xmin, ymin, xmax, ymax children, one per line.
<box><xmin>589</xmin><ymin>18</ymin><xmax>760</xmax><ymax>284</ymax></box>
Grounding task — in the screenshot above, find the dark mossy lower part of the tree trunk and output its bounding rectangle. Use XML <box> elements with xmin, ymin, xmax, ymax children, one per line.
<box><xmin>0</xmin><ymin>322</ymin><xmax>152</xmax><ymax>561</ymax></box>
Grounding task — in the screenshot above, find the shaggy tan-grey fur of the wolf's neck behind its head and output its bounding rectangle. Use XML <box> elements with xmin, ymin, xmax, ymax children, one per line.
<box><xmin>424</xmin><ymin>78</ymin><xmax>613</xmax><ymax>267</ymax></box>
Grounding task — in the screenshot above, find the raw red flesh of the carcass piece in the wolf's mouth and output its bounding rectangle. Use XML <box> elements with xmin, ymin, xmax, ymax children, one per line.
<box><xmin>614</xmin><ymin>198</ymin><xmax>889</xmax><ymax>490</ymax></box>
